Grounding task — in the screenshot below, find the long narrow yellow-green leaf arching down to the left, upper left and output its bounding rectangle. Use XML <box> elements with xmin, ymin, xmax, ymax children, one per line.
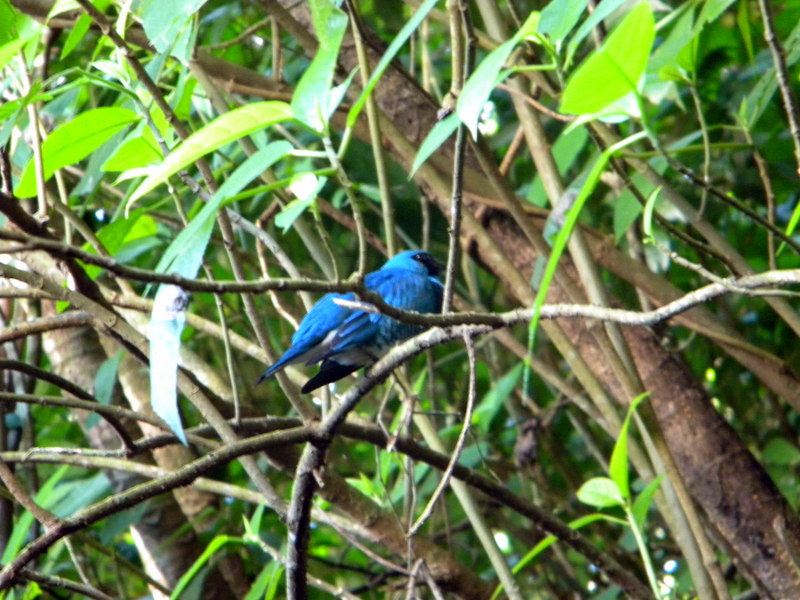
<box><xmin>127</xmin><ymin>100</ymin><xmax>292</xmax><ymax>209</ymax></box>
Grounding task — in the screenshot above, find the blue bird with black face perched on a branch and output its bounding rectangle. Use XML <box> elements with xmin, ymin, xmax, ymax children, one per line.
<box><xmin>256</xmin><ymin>250</ymin><xmax>443</xmax><ymax>394</ymax></box>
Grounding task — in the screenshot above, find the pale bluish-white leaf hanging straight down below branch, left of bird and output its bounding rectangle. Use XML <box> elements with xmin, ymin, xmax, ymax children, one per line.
<box><xmin>147</xmin><ymin>285</ymin><xmax>189</xmax><ymax>444</ymax></box>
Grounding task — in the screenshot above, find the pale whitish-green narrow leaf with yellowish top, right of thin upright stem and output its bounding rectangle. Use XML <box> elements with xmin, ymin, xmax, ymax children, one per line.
<box><xmin>456</xmin><ymin>12</ymin><xmax>539</xmax><ymax>139</ymax></box>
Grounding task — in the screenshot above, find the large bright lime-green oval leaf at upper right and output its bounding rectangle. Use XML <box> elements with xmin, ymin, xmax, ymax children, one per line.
<box><xmin>561</xmin><ymin>2</ymin><xmax>655</xmax><ymax>114</ymax></box>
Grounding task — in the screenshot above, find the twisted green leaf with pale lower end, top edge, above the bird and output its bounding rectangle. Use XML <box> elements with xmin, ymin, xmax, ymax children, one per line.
<box><xmin>292</xmin><ymin>0</ymin><xmax>347</xmax><ymax>132</ymax></box>
